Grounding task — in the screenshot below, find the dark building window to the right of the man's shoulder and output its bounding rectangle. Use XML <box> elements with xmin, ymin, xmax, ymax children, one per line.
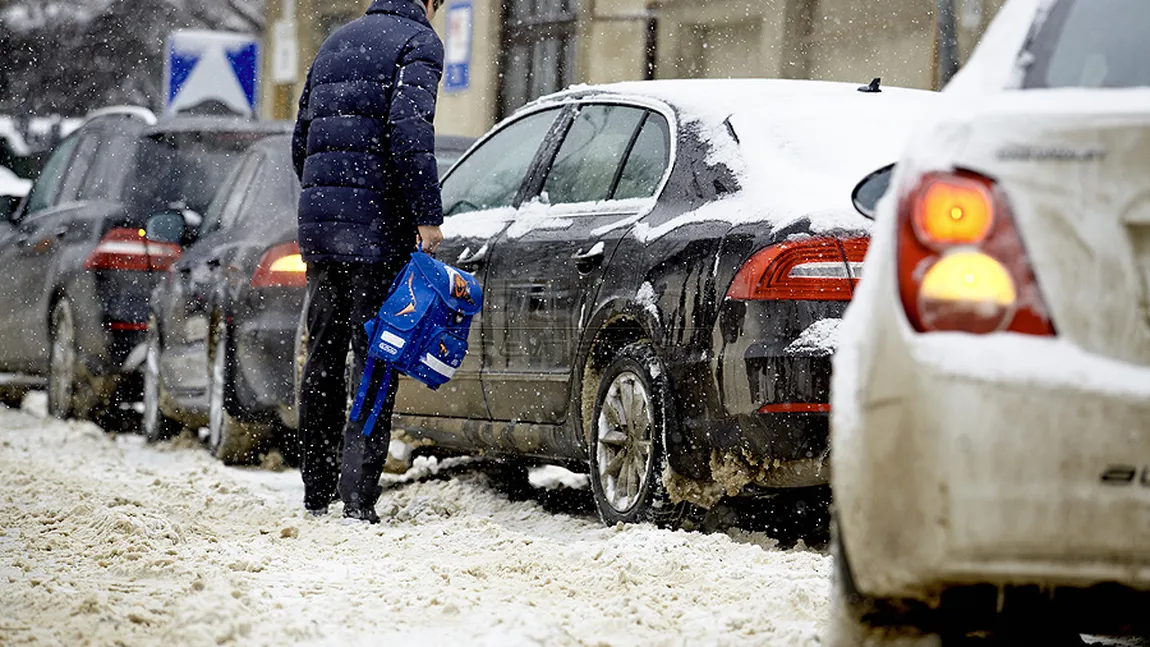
<box><xmin>498</xmin><ymin>0</ymin><xmax>576</xmax><ymax>118</ymax></box>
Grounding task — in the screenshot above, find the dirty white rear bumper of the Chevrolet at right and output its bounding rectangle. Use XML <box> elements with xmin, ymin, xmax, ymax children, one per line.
<box><xmin>834</xmin><ymin>330</ymin><xmax>1150</xmax><ymax>599</ymax></box>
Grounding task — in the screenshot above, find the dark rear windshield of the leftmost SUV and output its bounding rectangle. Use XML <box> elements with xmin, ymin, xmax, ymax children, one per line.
<box><xmin>128</xmin><ymin>132</ymin><xmax>265</xmax><ymax>218</ymax></box>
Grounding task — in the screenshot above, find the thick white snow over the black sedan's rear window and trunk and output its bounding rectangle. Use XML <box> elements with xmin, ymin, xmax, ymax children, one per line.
<box><xmin>601</xmin><ymin>79</ymin><xmax>936</xmax><ymax>239</ymax></box>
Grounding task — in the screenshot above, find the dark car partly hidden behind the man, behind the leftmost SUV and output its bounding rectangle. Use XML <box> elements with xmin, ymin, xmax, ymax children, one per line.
<box><xmin>143</xmin><ymin>137</ymin><xmax>474</xmax><ymax>463</ymax></box>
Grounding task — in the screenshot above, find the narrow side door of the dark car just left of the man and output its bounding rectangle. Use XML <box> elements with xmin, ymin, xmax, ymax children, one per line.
<box><xmin>160</xmin><ymin>153</ymin><xmax>262</xmax><ymax>398</ymax></box>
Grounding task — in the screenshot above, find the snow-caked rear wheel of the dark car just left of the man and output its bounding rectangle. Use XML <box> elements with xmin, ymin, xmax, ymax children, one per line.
<box><xmin>208</xmin><ymin>317</ymin><xmax>271</xmax><ymax>465</ymax></box>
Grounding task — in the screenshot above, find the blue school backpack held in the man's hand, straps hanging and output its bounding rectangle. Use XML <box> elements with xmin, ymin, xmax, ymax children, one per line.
<box><xmin>351</xmin><ymin>252</ymin><xmax>483</xmax><ymax>436</ymax></box>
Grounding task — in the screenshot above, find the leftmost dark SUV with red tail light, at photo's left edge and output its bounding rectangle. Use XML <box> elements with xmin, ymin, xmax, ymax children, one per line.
<box><xmin>0</xmin><ymin>108</ymin><xmax>286</xmax><ymax>418</ymax></box>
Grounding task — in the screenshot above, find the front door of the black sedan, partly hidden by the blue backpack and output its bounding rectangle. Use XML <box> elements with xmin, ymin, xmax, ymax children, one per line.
<box><xmin>396</xmin><ymin>107</ymin><xmax>562</xmax><ymax>419</ymax></box>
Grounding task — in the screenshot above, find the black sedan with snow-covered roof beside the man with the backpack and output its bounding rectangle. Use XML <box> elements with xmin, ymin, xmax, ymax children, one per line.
<box><xmin>377</xmin><ymin>80</ymin><xmax>935</xmax><ymax>525</ymax></box>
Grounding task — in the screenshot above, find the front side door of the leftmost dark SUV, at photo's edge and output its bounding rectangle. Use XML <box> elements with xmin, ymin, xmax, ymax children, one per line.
<box><xmin>0</xmin><ymin>133</ymin><xmax>85</xmax><ymax>371</ymax></box>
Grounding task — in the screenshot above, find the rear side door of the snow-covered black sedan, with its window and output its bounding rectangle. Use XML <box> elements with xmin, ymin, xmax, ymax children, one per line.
<box><xmin>484</xmin><ymin>102</ymin><xmax>669</xmax><ymax>424</ymax></box>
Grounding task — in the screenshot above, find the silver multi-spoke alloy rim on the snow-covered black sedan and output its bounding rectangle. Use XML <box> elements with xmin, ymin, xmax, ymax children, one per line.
<box><xmin>596</xmin><ymin>371</ymin><xmax>654</xmax><ymax>513</ymax></box>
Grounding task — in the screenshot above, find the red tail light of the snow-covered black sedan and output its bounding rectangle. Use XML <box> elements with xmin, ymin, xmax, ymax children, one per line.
<box><xmin>727</xmin><ymin>238</ymin><xmax>867</xmax><ymax>301</ymax></box>
